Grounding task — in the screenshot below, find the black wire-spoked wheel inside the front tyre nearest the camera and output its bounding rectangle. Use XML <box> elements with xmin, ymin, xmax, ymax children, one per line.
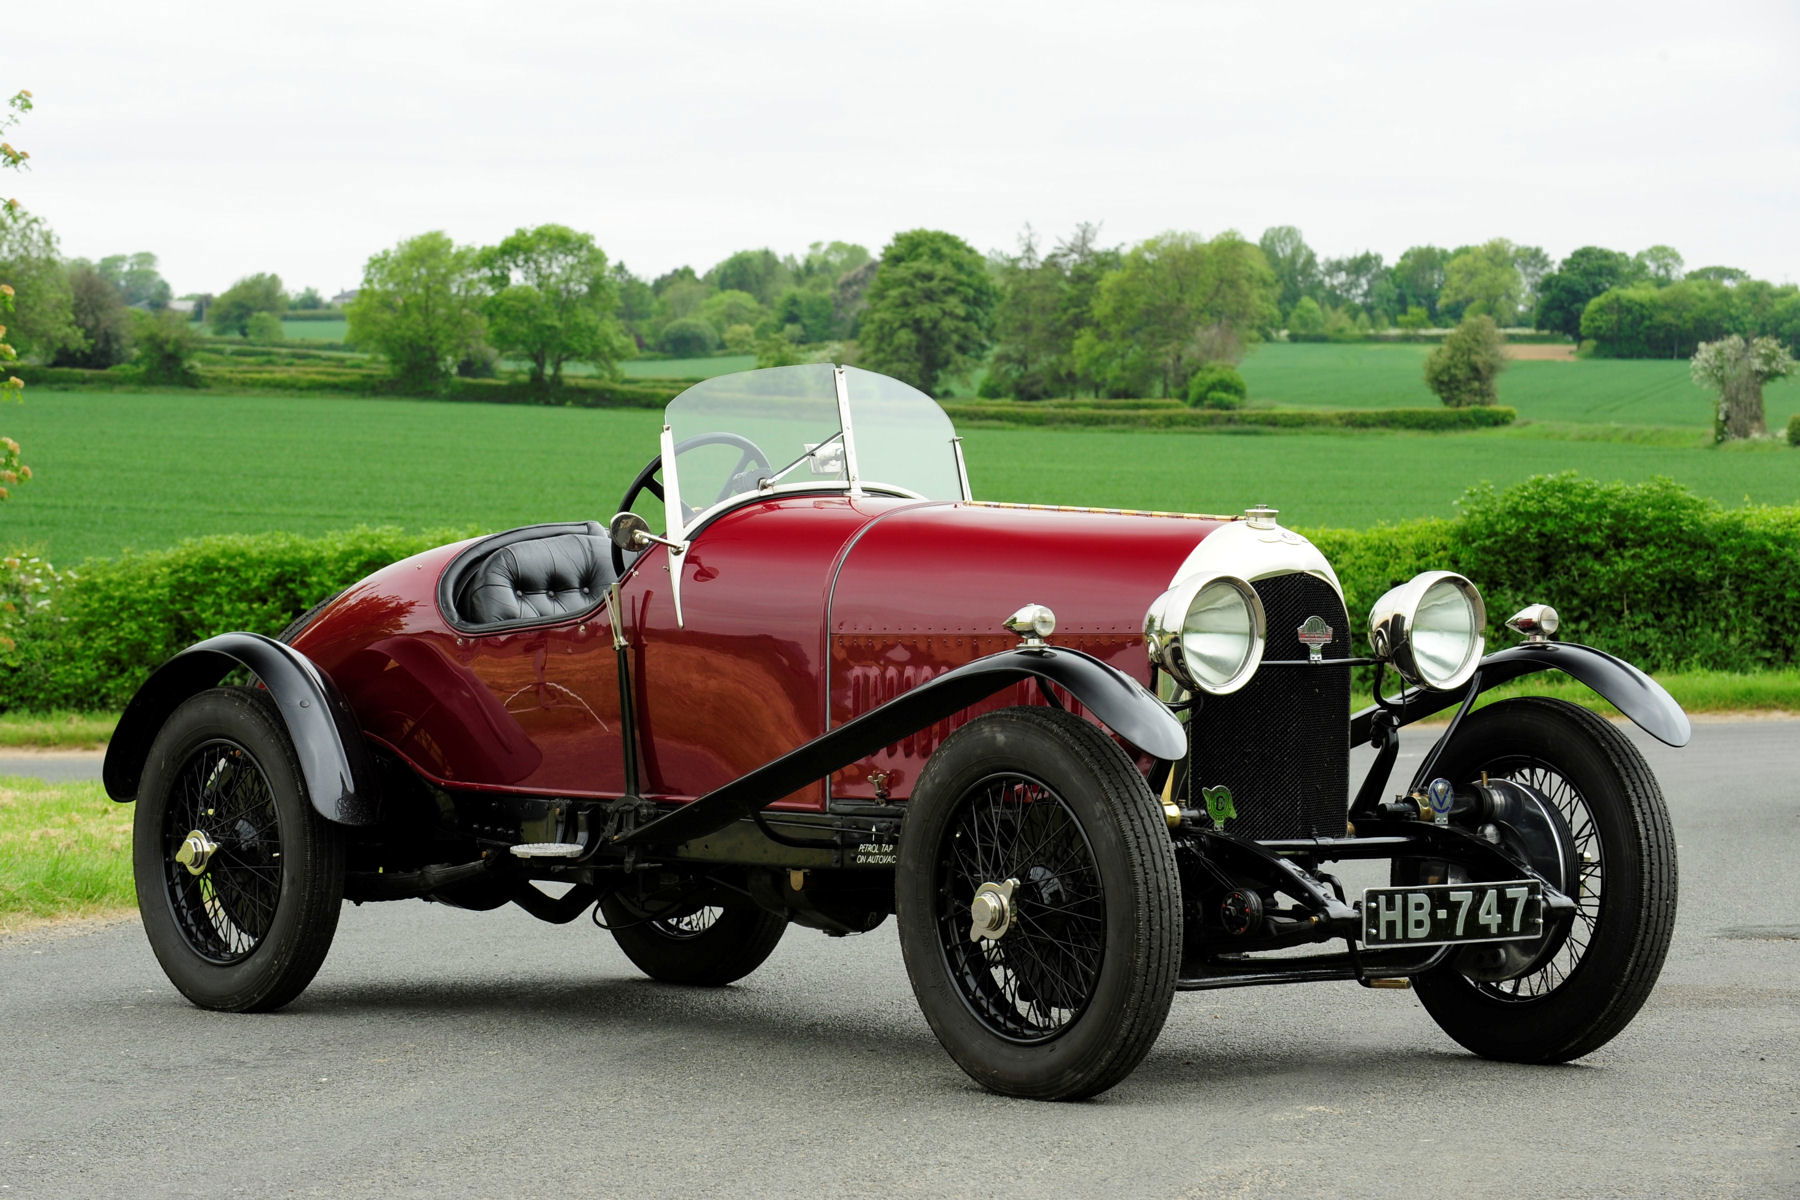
<box><xmin>938</xmin><ymin>774</ymin><xmax>1105</xmax><ymax>1043</ymax></box>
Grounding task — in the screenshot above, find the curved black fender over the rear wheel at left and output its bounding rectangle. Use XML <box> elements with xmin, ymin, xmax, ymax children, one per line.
<box><xmin>101</xmin><ymin>633</ymin><xmax>380</xmax><ymax>826</ymax></box>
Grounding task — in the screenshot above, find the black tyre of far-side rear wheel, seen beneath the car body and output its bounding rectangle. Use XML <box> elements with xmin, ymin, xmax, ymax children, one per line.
<box><xmin>599</xmin><ymin>896</ymin><xmax>787</xmax><ymax>988</ymax></box>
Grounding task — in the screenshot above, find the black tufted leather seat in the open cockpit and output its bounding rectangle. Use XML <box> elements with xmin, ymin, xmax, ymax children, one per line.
<box><xmin>455</xmin><ymin>533</ymin><xmax>614</xmax><ymax>624</ymax></box>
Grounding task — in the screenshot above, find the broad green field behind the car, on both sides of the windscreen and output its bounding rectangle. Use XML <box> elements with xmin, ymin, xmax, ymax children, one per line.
<box><xmin>0</xmin><ymin>390</ymin><xmax>1800</xmax><ymax>567</ymax></box>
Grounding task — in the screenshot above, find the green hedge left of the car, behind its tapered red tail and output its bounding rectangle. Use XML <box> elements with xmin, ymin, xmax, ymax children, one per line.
<box><xmin>0</xmin><ymin>529</ymin><xmax>475</xmax><ymax>712</ymax></box>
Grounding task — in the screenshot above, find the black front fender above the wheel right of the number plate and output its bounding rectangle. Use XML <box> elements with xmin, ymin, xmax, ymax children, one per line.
<box><xmin>1350</xmin><ymin>642</ymin><xmax>1694</xmax><ymax>747</ymax></box>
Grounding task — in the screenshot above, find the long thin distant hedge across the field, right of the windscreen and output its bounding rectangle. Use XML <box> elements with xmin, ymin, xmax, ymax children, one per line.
<box><xmin>943</xmin><ymin>401</ymin><xmax>1519</xmax><ymax>430</ymax></box>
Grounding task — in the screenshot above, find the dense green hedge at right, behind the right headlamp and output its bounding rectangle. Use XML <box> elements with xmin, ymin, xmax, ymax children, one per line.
<box><xmin>1312</xmin><ymin>473</ymin><xmax>1800</xmax><ymax>671</ymax></box>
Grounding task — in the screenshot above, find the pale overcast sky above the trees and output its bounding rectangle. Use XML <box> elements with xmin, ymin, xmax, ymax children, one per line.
<box><xmin>14</xmin><ymin>0</ymin><xmax>1800</xmax><ymax>295</ymax></box>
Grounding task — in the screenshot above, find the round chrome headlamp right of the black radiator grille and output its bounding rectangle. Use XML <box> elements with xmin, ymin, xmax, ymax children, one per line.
<box><xmin>1368</xmin><ymin>570</ymin><xmax>1487</xmax><ymax>691</ymax></box>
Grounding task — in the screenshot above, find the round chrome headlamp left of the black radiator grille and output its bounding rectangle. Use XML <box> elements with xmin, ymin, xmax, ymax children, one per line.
<box><xmin>1143</xmin><ymin>576</ymin><xmax>1267</xmax><ymax>696</ymax></box>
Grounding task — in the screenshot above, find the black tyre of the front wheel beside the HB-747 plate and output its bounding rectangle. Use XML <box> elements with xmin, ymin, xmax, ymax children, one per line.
<box><xmin>1415</xmin><ymin>698</ymin><xmax>1676</xmax><ymax>1063</ymax></box>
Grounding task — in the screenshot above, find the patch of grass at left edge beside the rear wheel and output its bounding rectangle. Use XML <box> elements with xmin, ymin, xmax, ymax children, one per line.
<box><xmin>0</xmin><ymin>777</ymin><xmax>135</xmax><ymax>934</ymax></box>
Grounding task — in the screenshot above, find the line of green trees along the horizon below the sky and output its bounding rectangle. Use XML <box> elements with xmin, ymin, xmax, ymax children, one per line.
<box><xmin>0</xmin><ymin>192</ymin><xmax>1800</xmax><ymax>405</ymax></box>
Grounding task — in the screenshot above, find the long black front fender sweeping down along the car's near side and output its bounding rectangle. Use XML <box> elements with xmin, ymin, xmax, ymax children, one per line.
<box><xmin>616</xmin><ymin>646</ymin><xmax>1188</xmax><ymax>846</ymax></box>
